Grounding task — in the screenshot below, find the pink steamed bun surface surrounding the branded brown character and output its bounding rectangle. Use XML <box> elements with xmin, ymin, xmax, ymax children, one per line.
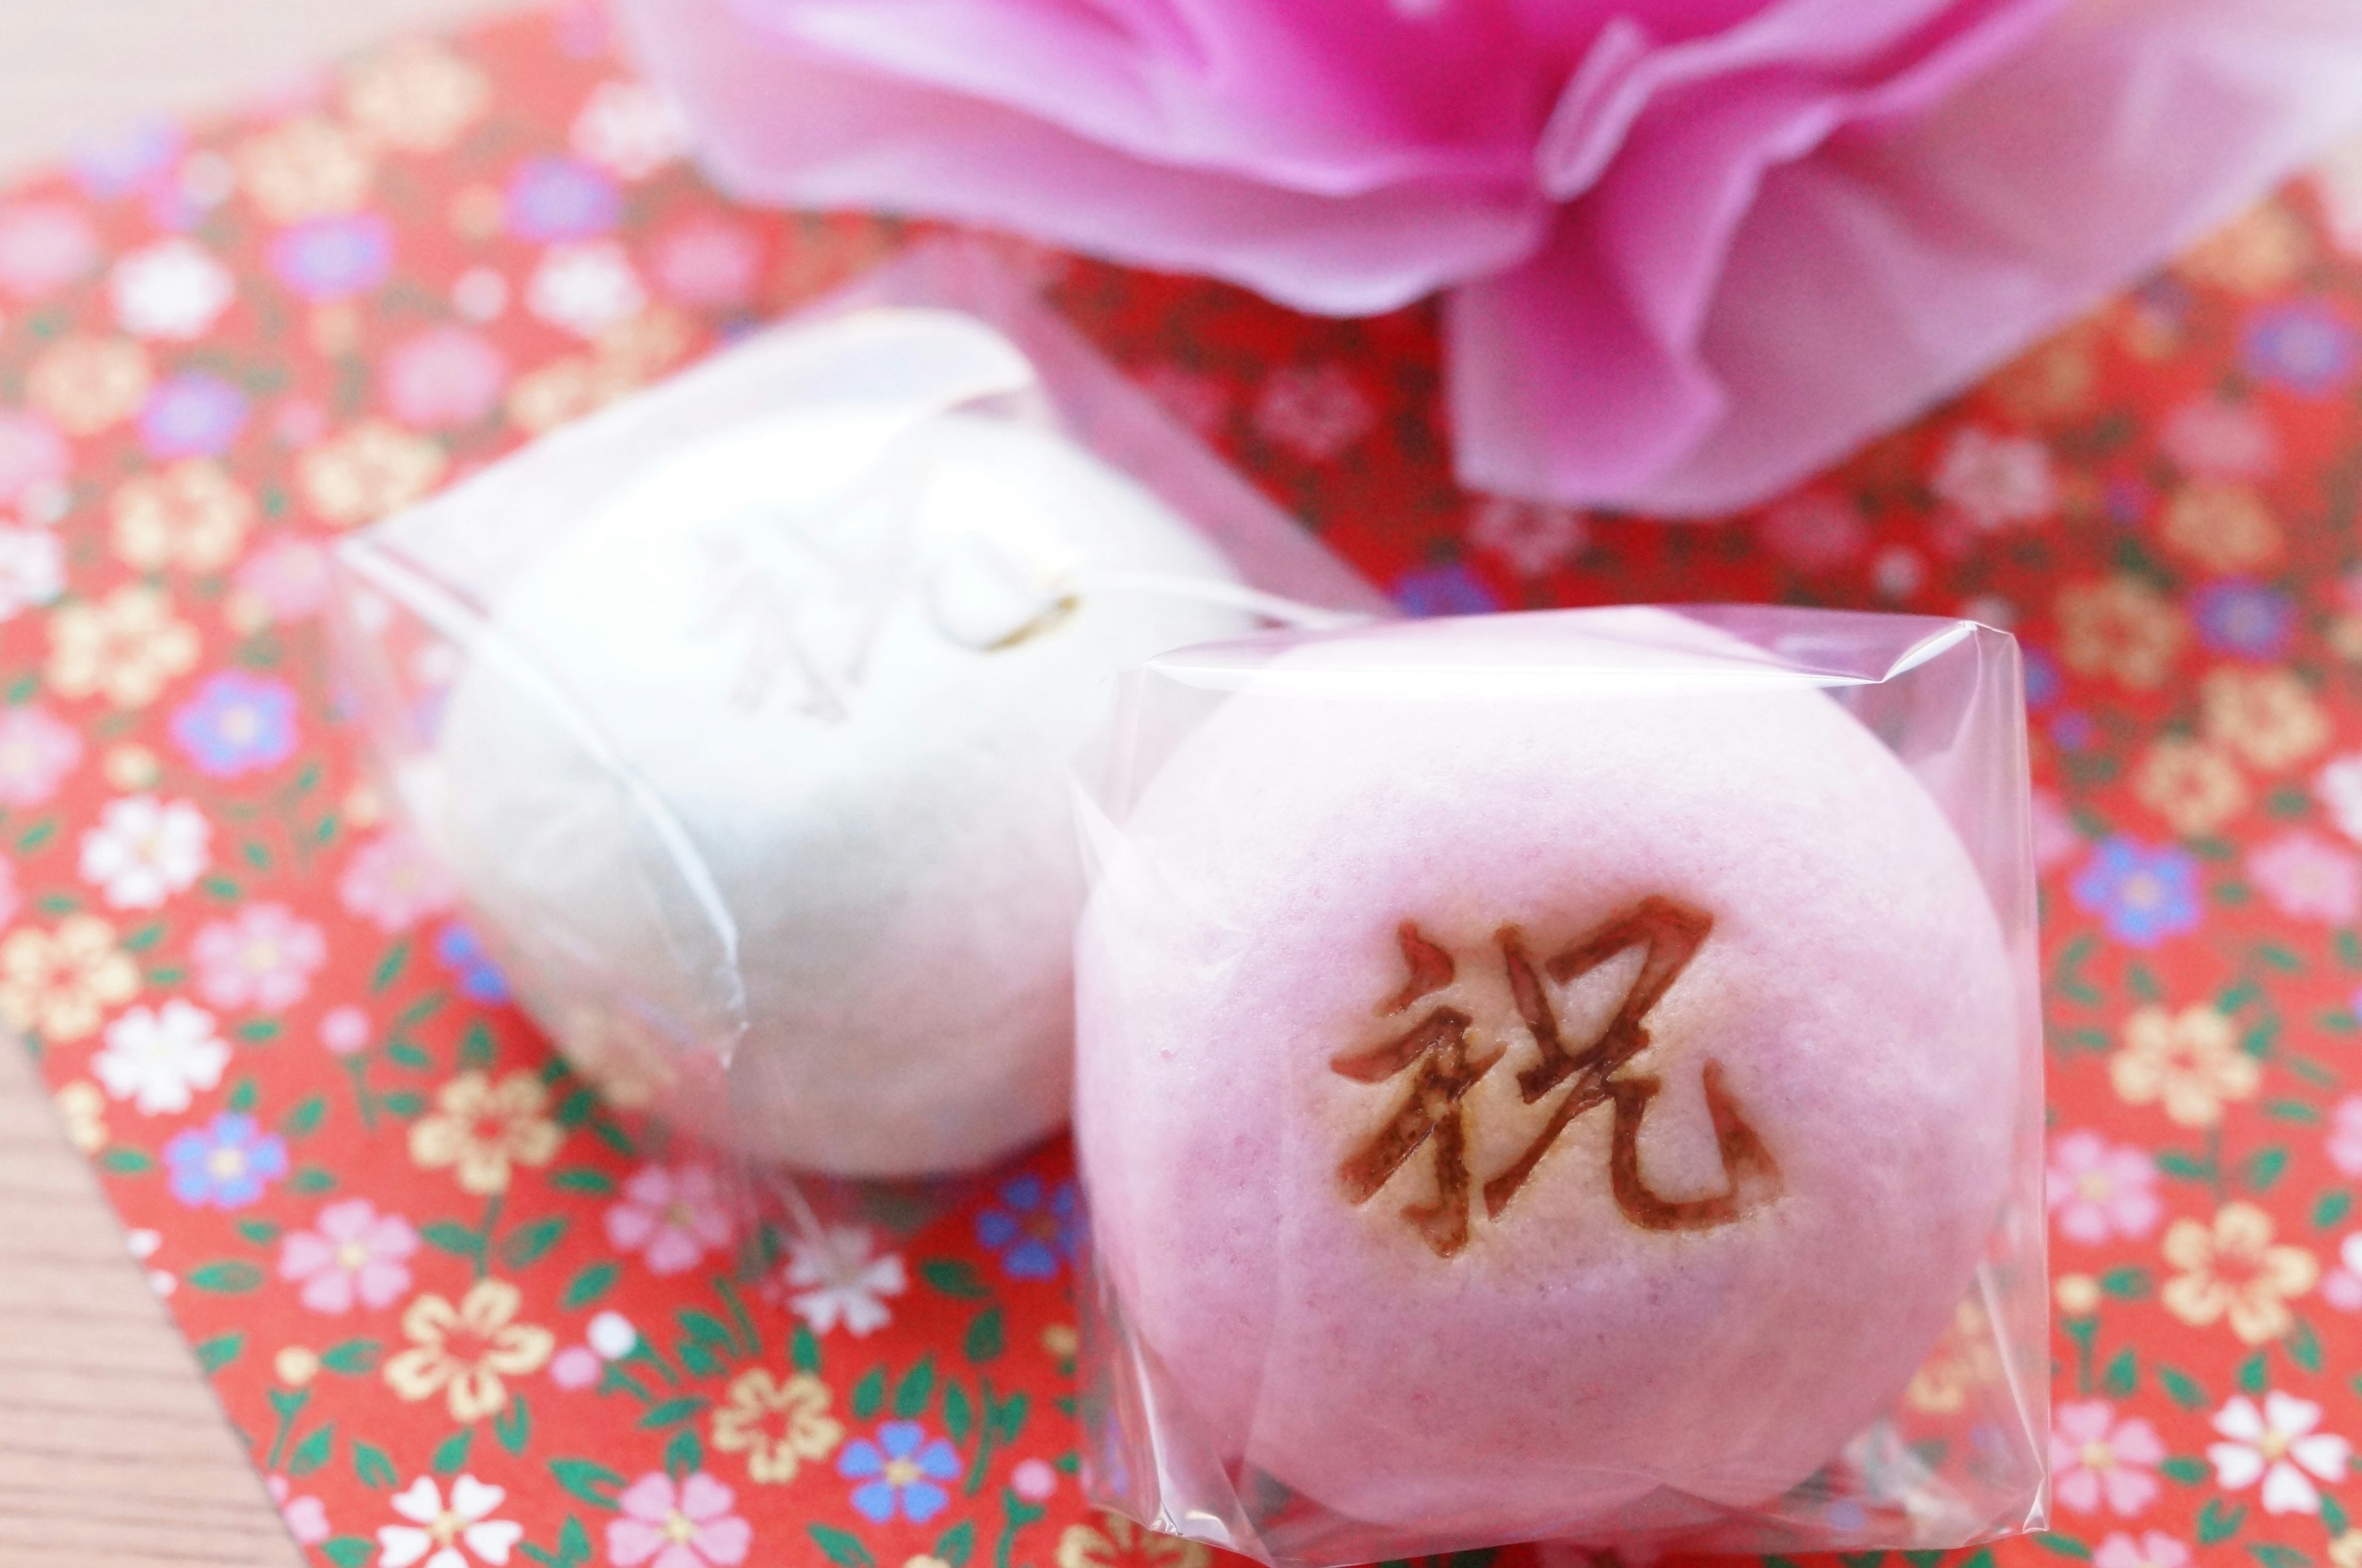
<box><xmin>1077</xmin><ymin>621</ymin><xmax>2034</xmax><ymax>1556</ymax></box>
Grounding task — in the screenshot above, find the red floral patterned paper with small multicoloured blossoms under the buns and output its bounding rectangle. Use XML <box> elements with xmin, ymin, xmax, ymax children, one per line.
<box><xmin>0</xmin><ymin>9</ymin><xmax>2362</xmax><ymax>1568</ymax></box>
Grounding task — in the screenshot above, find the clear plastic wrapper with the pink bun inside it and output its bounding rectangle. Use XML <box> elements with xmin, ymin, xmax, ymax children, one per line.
<box><xmin>1075</xmin><ymin>607</ymin><xmax>2050</xmax><ymax>1566</ymax></box>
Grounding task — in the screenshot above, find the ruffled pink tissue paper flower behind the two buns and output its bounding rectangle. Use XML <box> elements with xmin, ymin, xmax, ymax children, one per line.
<box><xmin>621</xmin><ymin>0</ymin><xmax>2362</xmax><ymax>512</ymax></box>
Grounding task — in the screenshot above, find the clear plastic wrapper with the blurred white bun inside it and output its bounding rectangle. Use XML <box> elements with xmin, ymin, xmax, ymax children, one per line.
<box><xmin>316</xmin><ymin>243</ymin><xmax>1384</xmax><ymax>1209</ymax></box>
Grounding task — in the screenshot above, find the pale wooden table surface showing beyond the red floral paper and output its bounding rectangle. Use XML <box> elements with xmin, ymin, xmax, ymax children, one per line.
<box><xmin>0</xmin><ymin>0</ymin><xmax>491</xmax><ymax>1568</ymax></box>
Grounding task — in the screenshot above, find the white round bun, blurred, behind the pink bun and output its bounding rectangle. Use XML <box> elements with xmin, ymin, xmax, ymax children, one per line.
<box><xmin>430</xmin><ymin>392</ymin><xmax>1254</xmax><ymax>1176</ymax></box>
